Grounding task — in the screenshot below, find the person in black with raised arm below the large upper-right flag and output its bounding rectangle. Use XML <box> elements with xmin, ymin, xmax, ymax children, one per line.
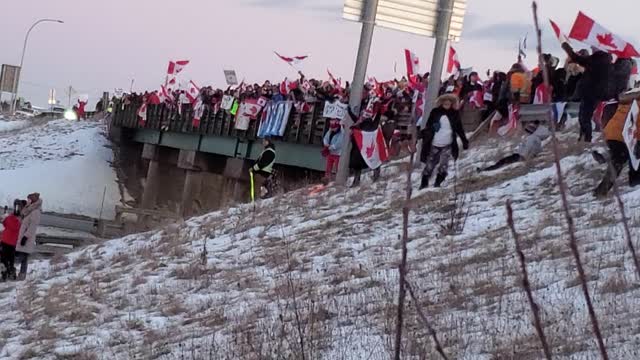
<box><xmin>562</xmin><ymin>43</ymin><xmax>612</xmax><ymax>142</ymax></box>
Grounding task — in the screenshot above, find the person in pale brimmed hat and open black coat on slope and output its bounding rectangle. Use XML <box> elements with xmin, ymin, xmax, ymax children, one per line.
<box><xmin>420</xmin><ymin>94</ymin><xmax>469</xmax><ymax>189</ymax></box>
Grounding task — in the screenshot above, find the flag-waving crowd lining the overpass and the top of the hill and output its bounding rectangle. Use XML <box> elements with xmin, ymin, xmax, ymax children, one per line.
<box><xmin>116</xmin><ymin>39</ymin><xmax>640</xmax><ymax>200</ymax></box>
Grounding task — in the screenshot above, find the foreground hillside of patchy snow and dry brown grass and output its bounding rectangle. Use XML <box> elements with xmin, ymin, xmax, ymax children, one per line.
<box><xmin>0</xmin><ymin>122</ymin><xmax>640</xmax><ymax>360</ymax></box>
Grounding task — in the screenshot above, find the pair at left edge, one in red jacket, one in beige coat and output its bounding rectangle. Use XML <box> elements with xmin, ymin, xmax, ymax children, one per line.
<box><xmin>0</xmin><ymin>193</ymin><xmax>42</xmax><ymax>281</ymax></box>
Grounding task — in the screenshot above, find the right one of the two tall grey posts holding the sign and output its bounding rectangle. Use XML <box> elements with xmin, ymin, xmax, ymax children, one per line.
<box><xmin>421</xmin><ymin>0</ymin><xmax>454</xmax><ymax>129</ymax></box>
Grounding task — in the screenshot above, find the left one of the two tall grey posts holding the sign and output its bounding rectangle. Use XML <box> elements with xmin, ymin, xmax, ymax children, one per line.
<box><xmin>336</xmin><ymin>0</ymin><xmax>378</xmax><ymax>185</ymax></box>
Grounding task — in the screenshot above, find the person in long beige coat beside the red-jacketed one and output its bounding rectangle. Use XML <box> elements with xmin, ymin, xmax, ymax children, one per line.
<box><xmin>16</xmin><ymin>193</ymin><xmax>42</xmax><ymax>280</ymax></box>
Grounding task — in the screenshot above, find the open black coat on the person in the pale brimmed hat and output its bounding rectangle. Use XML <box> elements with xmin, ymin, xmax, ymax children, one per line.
<box><xmin>420</xmin><ymin>107</ymin><xmax>469</xmax><ymax>163</ymax></box>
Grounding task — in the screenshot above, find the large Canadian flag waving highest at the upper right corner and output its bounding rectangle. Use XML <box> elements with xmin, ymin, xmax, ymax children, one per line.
<box><xmin>569</xmin><ymin>12</ymin><xmax>640</xmax><ymax>59</ymax></box>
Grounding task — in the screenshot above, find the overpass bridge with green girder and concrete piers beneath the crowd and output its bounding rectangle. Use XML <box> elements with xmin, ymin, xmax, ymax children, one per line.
<box><xmin>109</xmin><ymin>97</ymin><xmax>577</xmax><ymax>216</ymax></box>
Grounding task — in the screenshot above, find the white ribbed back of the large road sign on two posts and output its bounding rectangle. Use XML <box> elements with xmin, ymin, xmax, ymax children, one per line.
<box><xmin>342</xmin><ymin>0</ymin><xmax>467</xmax><ymax>42</ymax></box>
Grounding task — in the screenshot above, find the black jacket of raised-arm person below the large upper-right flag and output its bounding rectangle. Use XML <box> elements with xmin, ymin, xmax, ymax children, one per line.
<box><xmin>562</xmin><ymin>43</ymin><xmax>612</xmax><ymax>100</ymax></box>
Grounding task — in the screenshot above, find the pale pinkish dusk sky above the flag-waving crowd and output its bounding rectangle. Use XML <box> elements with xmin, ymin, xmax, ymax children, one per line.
<box><xmin>0</xmin><ymin>0</ymin><xmax>640</xmax><ymax>107</ymax></box>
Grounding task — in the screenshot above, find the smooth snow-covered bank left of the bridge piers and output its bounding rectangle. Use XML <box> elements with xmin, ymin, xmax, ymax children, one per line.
<box><xmin>0</xmin><ymin>120</ymin><xmax>121</xmax><ymax>218</ymax></box>
